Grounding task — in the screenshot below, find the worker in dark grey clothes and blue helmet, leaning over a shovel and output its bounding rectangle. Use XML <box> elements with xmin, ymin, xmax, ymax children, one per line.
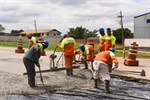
<box><xmin>23</xmin><ymin>40</ymin><xmax>49</xmax><ymax>87</ymax></box>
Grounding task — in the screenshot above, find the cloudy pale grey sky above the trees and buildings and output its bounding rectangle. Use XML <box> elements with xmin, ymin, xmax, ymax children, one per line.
<box><xmin>0</xmin><ymin>0</ymin><xmax>150</xmax><ymax>34</ymax></box>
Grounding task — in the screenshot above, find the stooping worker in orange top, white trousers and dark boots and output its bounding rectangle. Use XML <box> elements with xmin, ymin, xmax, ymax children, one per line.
<box><xmin>93</xmin><ymin>48</ymin><xmax>118</xmax><ymax>93</ymax></box>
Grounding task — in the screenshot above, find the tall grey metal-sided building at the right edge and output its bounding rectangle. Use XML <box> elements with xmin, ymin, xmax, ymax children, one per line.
<box><xmin>134</xmin><ymin>12</ymin><xmax>150</xmax><ymax>38</ymax></box>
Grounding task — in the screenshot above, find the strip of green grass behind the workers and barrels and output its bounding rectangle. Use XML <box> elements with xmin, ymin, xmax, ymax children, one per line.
<box><xmin>0</xmin><ymin>41</ymin><xmax>150</xmax><ymax>58</ymax></box>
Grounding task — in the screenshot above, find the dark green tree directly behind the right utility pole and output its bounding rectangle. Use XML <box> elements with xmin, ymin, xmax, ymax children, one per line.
<box><xmin>112</xmin><ymin>28</ymin><xmax>133</xmax><ymax>43</ymax></box>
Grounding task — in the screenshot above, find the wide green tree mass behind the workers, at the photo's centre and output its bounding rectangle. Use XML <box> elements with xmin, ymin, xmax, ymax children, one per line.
<box><xmin>67</xmin><ymin>26</ymin><xmax>97</xmax><ymax>39</ymax></box>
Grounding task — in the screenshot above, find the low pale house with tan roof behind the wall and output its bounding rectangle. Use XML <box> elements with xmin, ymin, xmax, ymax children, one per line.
<box><xmin>20</xmin><ymin>29</ymin><xmax>61</xmax><ymax>38</ymax></box>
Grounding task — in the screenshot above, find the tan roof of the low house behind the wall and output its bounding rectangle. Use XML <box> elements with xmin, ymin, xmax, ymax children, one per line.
<box><xmin>20</xmin><ymin>29</ymin><xmax>61</xmax><ymax>34</ymax></box>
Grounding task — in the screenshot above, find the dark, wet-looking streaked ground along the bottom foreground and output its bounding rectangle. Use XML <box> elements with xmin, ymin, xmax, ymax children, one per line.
<box><xmin>0</xmin><ymin>77</ymin><xmax>150</xmax><ymax>100</ymax></box>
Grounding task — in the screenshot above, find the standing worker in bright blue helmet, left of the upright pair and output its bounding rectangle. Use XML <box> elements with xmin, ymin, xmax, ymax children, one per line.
<box><xmin>98</xmin><ymin>28</ymin><xmax>106</xmax><ymax>52</ymax></box>
